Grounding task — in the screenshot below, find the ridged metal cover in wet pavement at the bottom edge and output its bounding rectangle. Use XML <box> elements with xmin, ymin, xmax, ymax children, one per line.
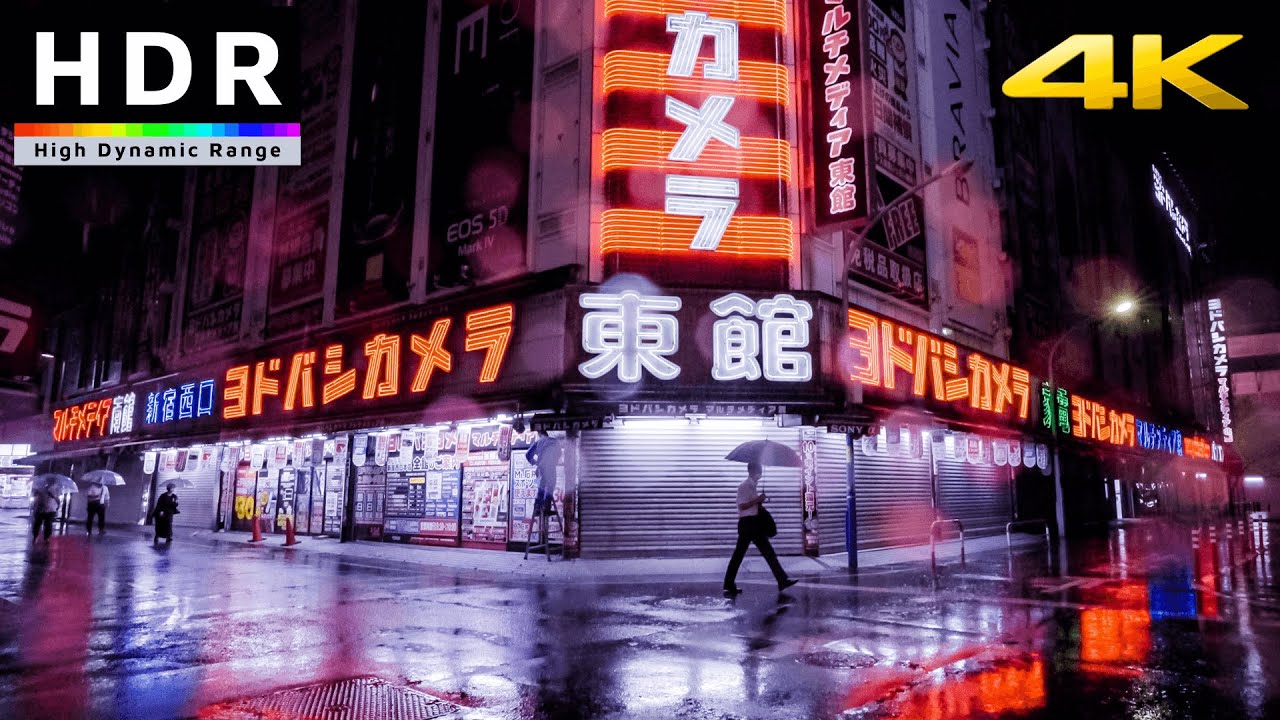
<box><xmin>197</xmin><ymin>678</ymin><xmax>458</xmax><ymax>720</ymax></box>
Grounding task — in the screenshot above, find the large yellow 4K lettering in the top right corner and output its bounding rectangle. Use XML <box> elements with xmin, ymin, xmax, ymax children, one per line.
<box><xmin>1002</xmin><ymin>35</ymin><xmax>1249</xmax><ymax>110</ymax></box>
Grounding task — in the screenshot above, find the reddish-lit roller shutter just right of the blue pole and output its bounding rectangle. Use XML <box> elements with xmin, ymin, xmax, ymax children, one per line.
<box><xmin>854</xmin><ymin>441</ymin><xmax>933</xmax><ymax>550</ymax></box>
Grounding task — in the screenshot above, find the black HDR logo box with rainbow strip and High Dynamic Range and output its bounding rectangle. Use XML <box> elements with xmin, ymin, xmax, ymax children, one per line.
<box><xmin>0</xmin><ymin>8</ymin><xmax>302</xmax><ymax>165</ymax></box>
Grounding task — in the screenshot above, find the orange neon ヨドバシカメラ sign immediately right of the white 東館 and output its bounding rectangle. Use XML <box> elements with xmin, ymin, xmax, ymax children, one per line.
<box><xmin>849</xmin><ymin>307</ymin><xmax>1032</xmax><ymax>420</ymax></box>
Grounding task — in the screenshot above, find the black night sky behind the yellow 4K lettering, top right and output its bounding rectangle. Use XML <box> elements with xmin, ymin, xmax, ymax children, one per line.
<box><xmin>1039</xmin><ymin>0</ymin><xmax>1280</xmax><ymax>282</ymax></box>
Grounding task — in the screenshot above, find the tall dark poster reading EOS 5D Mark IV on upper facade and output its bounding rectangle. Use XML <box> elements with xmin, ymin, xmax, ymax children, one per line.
<box><xmin>428</xmin><ymin>0</ymin><xmax>535</xmax><ymax>288</ymax></box>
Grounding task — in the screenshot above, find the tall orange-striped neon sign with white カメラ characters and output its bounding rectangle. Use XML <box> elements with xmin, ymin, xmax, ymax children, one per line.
<box><xmin>599</xmin><ymin>0</ymin><xmax>794</xmax><ymax>260</ymax></box>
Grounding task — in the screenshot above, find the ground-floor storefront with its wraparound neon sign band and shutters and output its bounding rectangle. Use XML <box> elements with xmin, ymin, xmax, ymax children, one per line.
<box><xmin>32</xmin><ymin>271</ymin><xmax>1221</xmax><ymax>557</ymax></box>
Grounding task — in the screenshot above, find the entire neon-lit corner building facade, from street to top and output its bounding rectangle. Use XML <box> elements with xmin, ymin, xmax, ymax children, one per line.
<box><xmin>17</xmin><ymin>0</ymin><xmax>1221</xmax><ymax>557</ymax></box>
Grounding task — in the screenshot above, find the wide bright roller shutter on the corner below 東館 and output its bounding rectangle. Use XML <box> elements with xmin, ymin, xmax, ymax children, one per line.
<box><xmin>577</xmin><ymin>419</ymin><xmax>803</xmax><ymax>557</ymax></box>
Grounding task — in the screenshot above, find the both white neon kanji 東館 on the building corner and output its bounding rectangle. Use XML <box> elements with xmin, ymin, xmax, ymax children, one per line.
<box><xmin>579</xmin><ymin>291</ymin><xmax>814</xmax><ymax>383</ymax></box>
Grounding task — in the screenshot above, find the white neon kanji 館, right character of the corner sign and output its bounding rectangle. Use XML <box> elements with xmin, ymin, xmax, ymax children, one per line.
<box><xmin>710</xmin><ymin>292</ymin><xmax>813</xmax><ymax>383</ymax></box>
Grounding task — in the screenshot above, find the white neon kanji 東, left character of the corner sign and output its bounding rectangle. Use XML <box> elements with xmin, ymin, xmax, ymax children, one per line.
<box><xmin>577</xmin><ymin>291</ymin><xmax>681</xmax><ymax>383</ymax></box>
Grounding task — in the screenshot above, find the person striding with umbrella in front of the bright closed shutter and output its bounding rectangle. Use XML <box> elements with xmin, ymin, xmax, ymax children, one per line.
<box><xmin>724</xmin><ymin>441</ymin><xmax>800</xmax><ymax>597</ymax></box>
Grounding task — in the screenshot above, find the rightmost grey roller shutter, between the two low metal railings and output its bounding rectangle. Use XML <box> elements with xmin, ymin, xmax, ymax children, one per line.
<box><xmin>937</xmin><ymin>446</ymin><xmax>1012</xmax><ymax>537</ymax></box>
